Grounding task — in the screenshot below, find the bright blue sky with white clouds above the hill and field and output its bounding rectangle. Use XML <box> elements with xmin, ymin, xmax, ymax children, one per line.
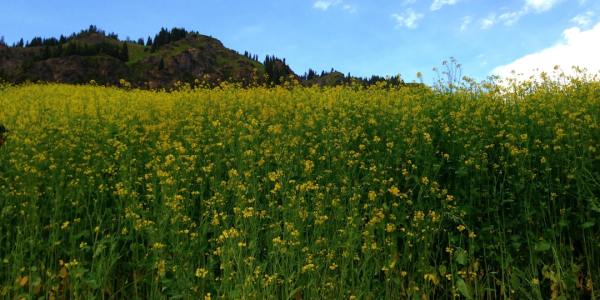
<box><xmin>0</xmin><ymin>0</ymin><xmax>600</xmax><ymax>81</ymax></box>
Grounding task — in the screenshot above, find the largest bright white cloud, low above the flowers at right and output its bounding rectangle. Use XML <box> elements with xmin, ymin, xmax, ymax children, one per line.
<box><xmin>492</xmin><ymin>23</ymin><xmax>600</xmax><ymax>79</ymax></box>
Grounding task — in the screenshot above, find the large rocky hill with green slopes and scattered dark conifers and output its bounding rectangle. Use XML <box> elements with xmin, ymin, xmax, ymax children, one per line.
<box><xmin>0</xmin><ymin>27</ymin><xmax>266</xmax><ymax>88</ymax></box>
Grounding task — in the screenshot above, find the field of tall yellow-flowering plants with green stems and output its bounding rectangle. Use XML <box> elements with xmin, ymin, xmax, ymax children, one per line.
<box><xmin>0</xmin><ymin>80</ymin><xmax>600</xmax><ymax>299</ymax></box>
